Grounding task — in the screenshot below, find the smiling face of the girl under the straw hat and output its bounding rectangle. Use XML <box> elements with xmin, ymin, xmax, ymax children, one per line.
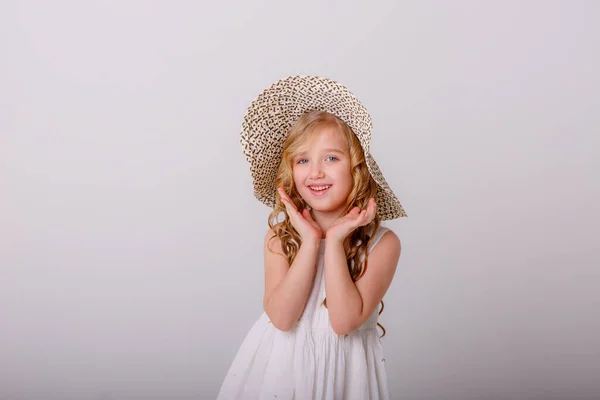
<box><xmin>293</xmin><ymin>126</ymin><xmax>353</xmax><ymax>217</ymax></box>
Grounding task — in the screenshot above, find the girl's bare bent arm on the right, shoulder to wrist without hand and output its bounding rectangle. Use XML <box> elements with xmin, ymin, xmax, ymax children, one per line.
<box><xmin>325</xmin><ymin>231</ymin><xmax>400</xmax><ymax>334</ymax></box>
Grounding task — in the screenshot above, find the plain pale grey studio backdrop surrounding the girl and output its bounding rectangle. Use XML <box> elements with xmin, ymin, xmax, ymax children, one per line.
<box><xmin>0</xmin><ymin>0</ymin><xmax>600</xmax><ymax>400</ymax></box>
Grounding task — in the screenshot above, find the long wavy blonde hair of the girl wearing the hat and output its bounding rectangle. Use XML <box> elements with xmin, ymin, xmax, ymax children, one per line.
<box><xmin>268</xmin><ymin>111</ymin><xmax>386</xmax><ymax>337</ymax></box>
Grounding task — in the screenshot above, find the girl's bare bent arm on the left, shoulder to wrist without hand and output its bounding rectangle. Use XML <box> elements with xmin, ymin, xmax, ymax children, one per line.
<box><xmin>263</xmin><ymin>229</ymin><xmax>319</xmax><ymax>331</ymax></box>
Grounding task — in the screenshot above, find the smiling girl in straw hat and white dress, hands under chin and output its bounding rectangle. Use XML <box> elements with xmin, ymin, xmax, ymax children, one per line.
<box><xmin>218</xmin><ymin>77</ymin><xmax>406</xmax><ymax>400</ymax></box>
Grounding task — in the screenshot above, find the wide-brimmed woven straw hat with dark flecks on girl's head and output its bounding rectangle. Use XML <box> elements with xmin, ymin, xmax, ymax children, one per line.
<box><xmin>241</xmin><ymin>76</ymin><xmax>406</xmax><ymax>220</ymax></box>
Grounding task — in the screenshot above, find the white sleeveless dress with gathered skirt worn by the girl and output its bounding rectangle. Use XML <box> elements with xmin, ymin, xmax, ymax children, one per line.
<box><xmin>217</xmin><ymin>227</ymin><xmax>390</xmax><ymax>400</ymax></box>
